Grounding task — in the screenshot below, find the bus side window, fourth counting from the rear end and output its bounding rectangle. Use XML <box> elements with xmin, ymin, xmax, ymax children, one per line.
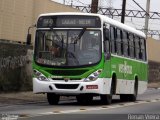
<box><xmin>123</xmin><ymin>31</ymin><xmax>128</xmax><ymax>56</ymax></box>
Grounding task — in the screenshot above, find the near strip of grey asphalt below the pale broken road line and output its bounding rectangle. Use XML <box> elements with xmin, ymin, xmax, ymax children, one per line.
<box><xmin>21</xmin><ymin>101</ymin><xmax>160</xmax><ymax>120</ymax></box>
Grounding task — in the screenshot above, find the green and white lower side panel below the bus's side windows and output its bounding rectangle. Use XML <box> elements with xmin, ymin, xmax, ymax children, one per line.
<box><xmin>111</xmin><ymin>55</ymin><xmax>147</xmax><ymax>94</ymax></box>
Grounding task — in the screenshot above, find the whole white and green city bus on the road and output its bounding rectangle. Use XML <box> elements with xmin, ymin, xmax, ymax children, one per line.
<box><xmin>30</xmin><ymin>12</ymin><xmax>148</xmax><ymax>105</ymax></box>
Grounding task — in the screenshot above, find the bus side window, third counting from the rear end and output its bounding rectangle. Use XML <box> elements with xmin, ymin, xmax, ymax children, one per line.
<box><xmin>129</xmin><ymin>34</ymin><xmax>134</xmax><ymax>58</ymax></box>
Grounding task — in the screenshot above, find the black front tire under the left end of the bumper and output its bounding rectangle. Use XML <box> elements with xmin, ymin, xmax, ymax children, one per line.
<box><xmin>47</xmin><ymin>93</ymin><xmax>60</xmax><ymax>105</ymax></box>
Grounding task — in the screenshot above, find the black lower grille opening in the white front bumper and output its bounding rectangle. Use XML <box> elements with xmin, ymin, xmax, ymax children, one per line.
<box><xmin>55</xmin><ymin>84</ymin><xmax>79</xmax><ymax>89</ymax></box>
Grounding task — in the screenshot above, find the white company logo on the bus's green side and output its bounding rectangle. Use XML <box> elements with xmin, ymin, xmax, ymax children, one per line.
<box><xmin>119</xmin><ymin>61</ymin><xmax>132</xmax><ymax>74</ymax></box>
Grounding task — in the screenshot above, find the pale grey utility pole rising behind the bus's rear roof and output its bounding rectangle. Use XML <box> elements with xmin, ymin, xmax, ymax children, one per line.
<box><xmin>144</xmin><ymin>0</ymin><xmax>150</xmax><ymax>36</ymax></box>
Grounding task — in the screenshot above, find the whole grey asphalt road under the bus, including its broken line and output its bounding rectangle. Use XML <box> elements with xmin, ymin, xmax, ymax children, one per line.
<box><xmin>0</xmin><ymin>89</ymin><xmax>160</xmax><ymax>120</ymax></box>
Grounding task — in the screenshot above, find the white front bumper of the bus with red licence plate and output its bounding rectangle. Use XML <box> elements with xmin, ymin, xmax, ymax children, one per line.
<box><xmin>33</xmin><ymin>78</ymin><xmax>111</xmax><ymax>95</ymax></box>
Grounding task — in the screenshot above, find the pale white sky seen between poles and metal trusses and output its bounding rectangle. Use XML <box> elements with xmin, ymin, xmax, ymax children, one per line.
<box><xmin>52</xmin><ymin>0</ymin><xmax>160</xmax><ymax>39</ymax></box>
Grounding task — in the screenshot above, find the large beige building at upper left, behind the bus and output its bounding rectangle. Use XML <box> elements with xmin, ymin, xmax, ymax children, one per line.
<box><xmin>0</xmin><ymin>0</ymin><xmax>78</xmax><ymax>43</ymax></box>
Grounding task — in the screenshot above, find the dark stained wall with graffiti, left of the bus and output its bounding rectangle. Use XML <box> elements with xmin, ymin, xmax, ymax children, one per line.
<box><xmin>0</xmin><ymin>43</ymin><xmax>32</xmax><ymax>92</ymax></box>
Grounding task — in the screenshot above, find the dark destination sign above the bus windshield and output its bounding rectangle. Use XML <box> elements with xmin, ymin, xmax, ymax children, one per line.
<box><xmin>37</xmin><ymin>15</ymin><xmax>101</xmax><ymax>28</ymax></box>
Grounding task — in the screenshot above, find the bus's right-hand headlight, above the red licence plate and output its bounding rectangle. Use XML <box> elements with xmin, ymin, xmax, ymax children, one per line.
<box><xmin>84</xmin><ymin>69</ymin><xmax>102</xmax><ymax>82</ymax></box>
